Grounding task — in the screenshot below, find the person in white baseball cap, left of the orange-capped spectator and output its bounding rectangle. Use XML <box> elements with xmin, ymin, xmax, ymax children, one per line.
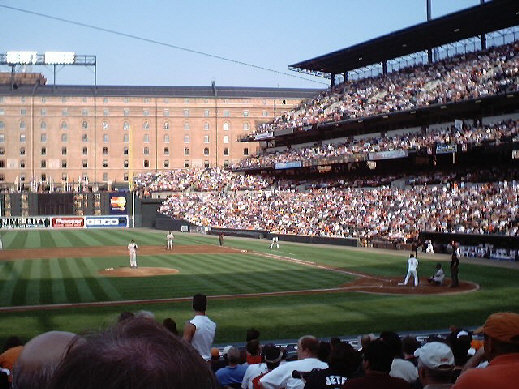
<box><xmin>414</xmin><ymin>342</ymin><xmax>454</xmax><ymax>389</ymax></box>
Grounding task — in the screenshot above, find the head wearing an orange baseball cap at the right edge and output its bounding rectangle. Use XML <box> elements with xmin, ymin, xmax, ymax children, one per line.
<box><xmin>474</xmin><ymin>312</ymin><xmax>519</xmax><ymax>359</ymax></box>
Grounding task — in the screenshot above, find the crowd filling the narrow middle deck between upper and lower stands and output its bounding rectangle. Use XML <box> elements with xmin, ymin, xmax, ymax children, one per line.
<box><xmin>237</xmin><ymin>120</ymin><xmax>519</xmax><ymax>169</ymax></box>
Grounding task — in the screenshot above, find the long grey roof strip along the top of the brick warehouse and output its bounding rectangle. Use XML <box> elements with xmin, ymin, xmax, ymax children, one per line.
<box><xmin>0</xmin><ymin>84</ymin><xmax>321</xmax><ymax>99</ymax></box>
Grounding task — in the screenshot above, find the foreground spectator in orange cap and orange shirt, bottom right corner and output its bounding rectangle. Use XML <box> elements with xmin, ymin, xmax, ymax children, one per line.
<box><xmin>453</xmin><ymin>312</ymin><xmax>519</xmax><ymax>389</ymax></box>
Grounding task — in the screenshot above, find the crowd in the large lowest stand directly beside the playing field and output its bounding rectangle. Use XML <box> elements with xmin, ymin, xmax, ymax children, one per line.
<box><xmin>160</xmin><ymin>181</ymin><xmax>519</xmax><ymax>242</ymax></box>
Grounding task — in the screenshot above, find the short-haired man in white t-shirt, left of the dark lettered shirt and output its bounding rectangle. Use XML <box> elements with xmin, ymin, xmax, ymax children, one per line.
<box><xmin>260</xmin><ymin>335</ymin><xmax>328</xmax><ymax>389</ymax></box>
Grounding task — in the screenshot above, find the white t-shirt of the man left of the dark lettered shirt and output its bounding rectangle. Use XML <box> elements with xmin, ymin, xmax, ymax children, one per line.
<box><xmin>260</xmin><ymin>358</ymin><xmax>328</xmax><ymax>389</ymax></box>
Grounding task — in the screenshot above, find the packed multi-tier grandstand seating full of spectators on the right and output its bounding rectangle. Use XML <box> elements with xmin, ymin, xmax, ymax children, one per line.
<box><xmin>135</xmin><ymin>38</ymin><xmax>519</xmax><ymax>249</ymax></box>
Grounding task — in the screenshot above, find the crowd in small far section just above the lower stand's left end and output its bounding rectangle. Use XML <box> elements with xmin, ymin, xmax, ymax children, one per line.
<box><xmin>134</xmin><ymin>167</ymin><xmax>272</xmax><ymax>197</ymax></box>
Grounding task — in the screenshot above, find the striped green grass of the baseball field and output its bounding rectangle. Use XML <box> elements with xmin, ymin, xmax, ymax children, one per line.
<box><xmin>0</xmin><ymin>229</ymin><xmax>519</xmax><ymax>343</ymax></box>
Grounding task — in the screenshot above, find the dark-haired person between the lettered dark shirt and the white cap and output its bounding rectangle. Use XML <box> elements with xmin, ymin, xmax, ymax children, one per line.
<box><xmin>343</xmin><ymin>339</ymin><xmax>412</xmax><ymax>389</ymax></box>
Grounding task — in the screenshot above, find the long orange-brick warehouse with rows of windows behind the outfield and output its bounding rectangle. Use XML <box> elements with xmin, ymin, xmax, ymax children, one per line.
<box><xmin>0</xmin><ymin>74</ymin><xmax>318</xmax><ymax>188</ymax></box>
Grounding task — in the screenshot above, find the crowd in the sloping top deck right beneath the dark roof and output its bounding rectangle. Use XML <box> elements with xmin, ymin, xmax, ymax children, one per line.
<box><xmin>257</xmin><ymin>42</ymin><xmax>519</xmax><ymax>137</ymax></box>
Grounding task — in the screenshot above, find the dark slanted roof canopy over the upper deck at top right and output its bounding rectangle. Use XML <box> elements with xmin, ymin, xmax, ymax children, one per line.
<box><xmin>289</xmin><ymin>0</ymin><xmax>519</xmax><ymax>74</ymax></box>
